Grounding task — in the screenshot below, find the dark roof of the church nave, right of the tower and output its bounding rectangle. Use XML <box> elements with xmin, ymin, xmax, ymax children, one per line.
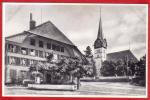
<box><xmin>107</xmin><ymin>50</ymin><xmax>138</xmax><ymax>62</ymax></box>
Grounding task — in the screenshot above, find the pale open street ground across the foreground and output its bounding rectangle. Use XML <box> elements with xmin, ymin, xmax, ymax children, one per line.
<box><xmin>4</xmin><ymin>82</ymin><xmax>146</xmax><ymax>97</ymax></box>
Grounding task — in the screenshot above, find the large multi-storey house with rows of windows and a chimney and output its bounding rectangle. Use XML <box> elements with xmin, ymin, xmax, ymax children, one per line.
<box><xmin>5</xmin><ymin>14</ymin><xmax>82</xmax><ymax>83</ymax></box>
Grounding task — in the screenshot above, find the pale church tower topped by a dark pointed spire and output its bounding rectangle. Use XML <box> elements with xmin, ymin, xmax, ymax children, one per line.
<box><xmin>94</xmin><ymin>9</ymin><xmax>107</xmax><ymax>78</ymax></box>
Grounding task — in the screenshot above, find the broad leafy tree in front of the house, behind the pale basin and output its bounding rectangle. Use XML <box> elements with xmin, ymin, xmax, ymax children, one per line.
<box><xmin>30</xmin><ymin>56</ymin><xmax>85</xmax><ymax>87</ymax></box>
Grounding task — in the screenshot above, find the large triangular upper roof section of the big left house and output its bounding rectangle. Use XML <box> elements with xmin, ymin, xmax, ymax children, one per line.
<box><xmin>27</xmin><ymin>21</ymin><xmax>74</xmax><ymax>45</ymax></box>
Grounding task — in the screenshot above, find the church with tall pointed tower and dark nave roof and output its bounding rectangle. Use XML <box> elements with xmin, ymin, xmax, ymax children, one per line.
<box><xmin>93</xmin><ymin>11</ymin><xmax>138</xmax><ymax>78</ymax></box>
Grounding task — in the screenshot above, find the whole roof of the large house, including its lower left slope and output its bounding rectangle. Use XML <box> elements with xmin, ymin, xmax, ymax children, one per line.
<box><xmin>6</xmin><ymin>21</ymin><xmax>74</xmax><ymax>45</ymax></box>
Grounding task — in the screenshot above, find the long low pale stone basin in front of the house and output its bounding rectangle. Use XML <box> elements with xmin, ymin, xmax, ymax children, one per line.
<box><xmin>28</xmin><ymin>84</ymin><xmax>77</xmax><ymax>91</ymax></box>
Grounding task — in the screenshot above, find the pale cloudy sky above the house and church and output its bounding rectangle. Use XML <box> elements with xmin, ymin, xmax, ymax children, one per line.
<box><xmin>3</xmin><ymin>3</ymin><xmax>147</xmax><ymax>59</ymax></box>
